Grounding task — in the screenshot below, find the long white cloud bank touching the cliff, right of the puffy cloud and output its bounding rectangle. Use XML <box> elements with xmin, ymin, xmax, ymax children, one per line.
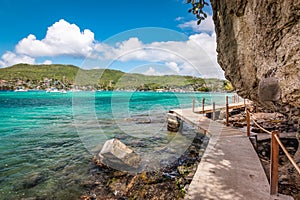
<box><xmin>91</xmin><ymin>33</ymin><xmax>224</xmax><ymax>78</ymax></box>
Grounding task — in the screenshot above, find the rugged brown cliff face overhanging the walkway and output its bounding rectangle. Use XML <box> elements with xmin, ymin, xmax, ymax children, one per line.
<box><xmin>211</xmin><ymin>0</ymin><xmax>300</xmax><ymax>117</ymax></box>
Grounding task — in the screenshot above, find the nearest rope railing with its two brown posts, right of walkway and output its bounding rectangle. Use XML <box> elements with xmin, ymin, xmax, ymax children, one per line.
<box><xmin>246</xmin><ymin>108</ymin><xmax>300</xmax><ymax>195</ymax></box>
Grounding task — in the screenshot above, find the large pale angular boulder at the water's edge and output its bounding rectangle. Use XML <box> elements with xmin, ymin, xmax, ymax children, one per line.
<box><xmin>98</xmin><ymin>139</ymin><xmax>141</xmax><ymax>171</ymax></box>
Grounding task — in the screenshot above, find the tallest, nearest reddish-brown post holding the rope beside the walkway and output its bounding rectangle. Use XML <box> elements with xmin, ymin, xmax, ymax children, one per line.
<box><xmin>270</xmin><ymin>131</ymin><xmax>279</xmax><ymax>195</ymax></box>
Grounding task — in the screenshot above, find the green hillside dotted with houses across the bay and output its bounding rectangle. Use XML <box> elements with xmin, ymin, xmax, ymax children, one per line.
<box><xmin>0</xmin><ymin>64</ymin><xmax>232</xmax><ymax>92</ymax></box>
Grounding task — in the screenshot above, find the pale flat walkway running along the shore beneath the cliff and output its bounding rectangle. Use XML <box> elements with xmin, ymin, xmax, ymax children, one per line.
<box><xmin>170</xmin><ymin>108</ymin><xmax>293</xmax><ymax>200</ymax></box>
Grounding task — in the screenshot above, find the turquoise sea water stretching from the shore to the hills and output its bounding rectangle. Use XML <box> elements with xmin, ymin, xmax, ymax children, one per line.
<box><xmin>0</xmin><ymin>91</ymin><xmax>231</xmax><ymax>199</ymax></box>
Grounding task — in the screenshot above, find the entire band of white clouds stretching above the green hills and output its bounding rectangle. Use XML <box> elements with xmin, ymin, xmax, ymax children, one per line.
<box><xmin>0</xmin><ymin>16</ymin><xmax>224</xmax><ymax>78</ymax></box>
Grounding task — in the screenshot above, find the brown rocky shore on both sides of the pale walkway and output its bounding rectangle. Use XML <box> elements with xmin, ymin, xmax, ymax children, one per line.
<box><xmin>80</xmin><ymin>109</ymin><xmax>300</xmax><ymax>200</ymax></box>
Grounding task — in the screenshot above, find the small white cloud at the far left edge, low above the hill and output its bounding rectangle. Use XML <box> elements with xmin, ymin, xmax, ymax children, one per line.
<box><xmin>0</xmin><ymin>51</ymin><xmax>35</xmax><ymax>67</ymax></box>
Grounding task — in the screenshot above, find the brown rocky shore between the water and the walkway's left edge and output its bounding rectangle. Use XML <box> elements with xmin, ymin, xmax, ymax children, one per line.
<box><xmin>80</xmin><ymin>127</ymin><xmax>208</xmax><ymax>200</ymax></box>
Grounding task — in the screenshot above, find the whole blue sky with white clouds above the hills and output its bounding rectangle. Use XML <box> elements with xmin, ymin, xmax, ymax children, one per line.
<box><xmin>0</xmin><ymin>0</ymin><xmax>224</xmax><ymax>79</ymax></box>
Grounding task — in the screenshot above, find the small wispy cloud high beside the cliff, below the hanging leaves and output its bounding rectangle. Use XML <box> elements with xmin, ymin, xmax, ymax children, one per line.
<box><xmin>178</xmin><ymin>15</ymin><xmax>215</xmax><ymax>33</ymax></box>
